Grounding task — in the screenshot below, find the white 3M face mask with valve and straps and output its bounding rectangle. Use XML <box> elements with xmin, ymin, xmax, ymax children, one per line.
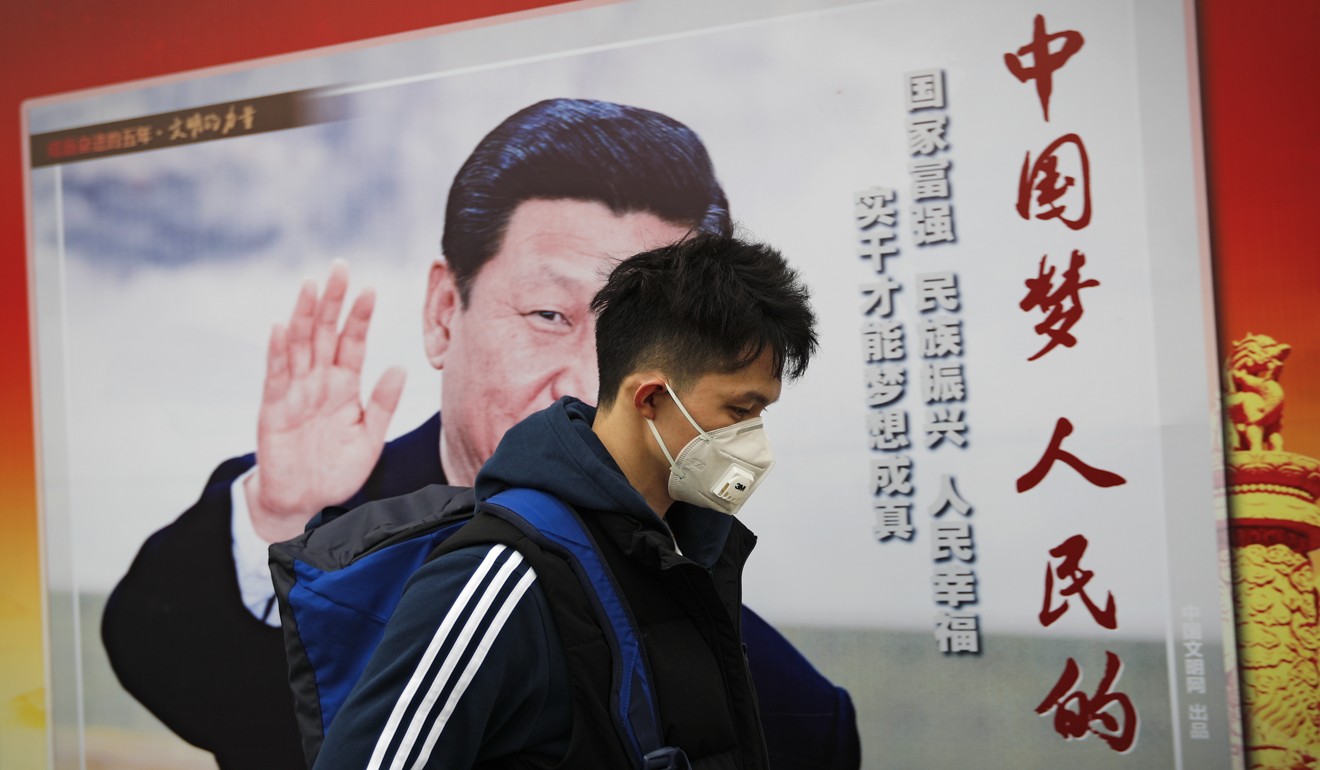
<box><xmin>647</xmin><ymin>386</ymin><xmax>775</xmax><ymax>514</ymax></box>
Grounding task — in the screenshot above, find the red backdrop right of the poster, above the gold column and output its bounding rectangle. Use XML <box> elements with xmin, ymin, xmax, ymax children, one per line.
<box><xmin>1199</xmin><ymin>0</ymin><xmax>1320</xmax><ymax>457</ymax></box>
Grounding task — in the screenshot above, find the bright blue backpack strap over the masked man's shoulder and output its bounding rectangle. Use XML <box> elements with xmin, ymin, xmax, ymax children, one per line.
<box><xmin>486</xmin><ymin>489</ymin><xmax>689</xmax><ymax>770</ymax></box>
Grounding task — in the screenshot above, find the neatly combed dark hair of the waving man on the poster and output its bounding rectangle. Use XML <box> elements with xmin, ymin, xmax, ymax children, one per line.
<box><xmin>441</xmin><ymin>99</ymin><xmax>731</xmax><ymax>305</ymax></box>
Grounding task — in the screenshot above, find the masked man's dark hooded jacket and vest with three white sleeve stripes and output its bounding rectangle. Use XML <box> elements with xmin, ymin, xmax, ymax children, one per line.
<box><xmin>317</xmin><ymin>398</ymin><xmax>767</xmax><ymax>770</ymax></box>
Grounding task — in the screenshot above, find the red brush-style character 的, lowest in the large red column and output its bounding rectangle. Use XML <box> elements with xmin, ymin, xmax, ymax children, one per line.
<box><xmin>1036</xmin><ymin>650</ymin><xmax>1139</xmax><ymax>753</ymax></box>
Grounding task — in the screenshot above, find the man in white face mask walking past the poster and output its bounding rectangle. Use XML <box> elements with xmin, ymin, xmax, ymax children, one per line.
<box><xmin>317</xmin><ymin>235</ymin><xmax>816</xmax><ymax>770</ymax></box>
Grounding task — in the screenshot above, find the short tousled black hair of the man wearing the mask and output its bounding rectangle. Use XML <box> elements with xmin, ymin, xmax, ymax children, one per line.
<box><xmin>591</xmin><ymin>234</ymin><xmax>817</xmax><ymax>408</ymax></box>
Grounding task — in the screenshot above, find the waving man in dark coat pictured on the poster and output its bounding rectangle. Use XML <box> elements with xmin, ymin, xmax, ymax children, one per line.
<box><xmin>103</xmin><ymin>99</ymin><xmax>857</xmax><ymax>769</ymax></box>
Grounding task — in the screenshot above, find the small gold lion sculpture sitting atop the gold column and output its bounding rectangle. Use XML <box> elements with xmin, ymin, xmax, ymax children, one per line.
<box><xmin>1224</xmin><ymin>332</ymin><xmax>1292</xmax><ymax>452</ymax></box>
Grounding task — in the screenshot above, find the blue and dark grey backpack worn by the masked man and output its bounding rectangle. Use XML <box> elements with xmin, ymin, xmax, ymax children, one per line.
<box><xmin>262</xmin><ymin>485</ymin><xmax>689</xmax><ymax>770</ymax></box>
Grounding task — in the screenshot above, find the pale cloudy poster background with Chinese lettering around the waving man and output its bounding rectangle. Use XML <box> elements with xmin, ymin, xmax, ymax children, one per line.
<box><xmin>29</xmin><ymin>3</ymin><xmax>1232</xmax><ymax>767</ymax></box>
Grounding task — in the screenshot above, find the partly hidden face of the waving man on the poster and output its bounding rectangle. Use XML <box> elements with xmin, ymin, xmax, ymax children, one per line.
<box><xmin>425</xmin><ymin>199</ymin><xmax>688</xmax><ymax>485</ymax></box>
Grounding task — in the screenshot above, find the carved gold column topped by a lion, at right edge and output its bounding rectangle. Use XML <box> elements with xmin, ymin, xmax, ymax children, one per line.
<box><xmin>1225</xmin><ymin>334</ymin><xmax>1320</xmax><ymax>770</ymax></box>
